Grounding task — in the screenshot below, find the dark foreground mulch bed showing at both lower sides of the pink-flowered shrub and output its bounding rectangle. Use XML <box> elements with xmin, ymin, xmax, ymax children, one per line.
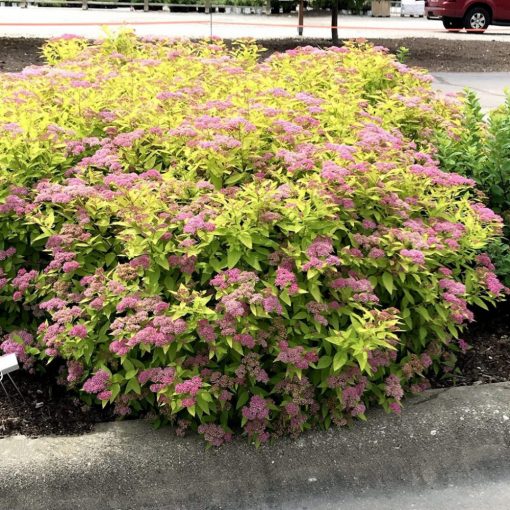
<box><xmin>0</xmin><ymin>302</ymin><xmax>510</xmax><ymax>438</ymax></box>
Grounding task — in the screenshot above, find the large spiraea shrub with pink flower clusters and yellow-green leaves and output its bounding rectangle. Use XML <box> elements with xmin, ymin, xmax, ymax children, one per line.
<box><xmin>0</xmin><ymin>33</ymin><xmax>506</xmax><ymax>445</ymax></box>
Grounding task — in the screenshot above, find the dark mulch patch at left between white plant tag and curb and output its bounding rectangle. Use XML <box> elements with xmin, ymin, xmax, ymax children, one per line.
<box><xmin>0</xmin><ymin>370</ymin><xmax>112</xmax><ymax>439</ymax></box>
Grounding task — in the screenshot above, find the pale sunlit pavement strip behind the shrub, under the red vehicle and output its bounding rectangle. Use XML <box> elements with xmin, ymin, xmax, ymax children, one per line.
<box><xmin>0</xmin><ymin>7</ymin><xmax>510</xmax><ymax>41</ymax></box>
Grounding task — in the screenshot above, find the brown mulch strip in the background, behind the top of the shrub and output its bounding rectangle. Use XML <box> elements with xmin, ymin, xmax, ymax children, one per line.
<box><xmin>0</xmin><ymin>34</ymin><xmax>510</xmax><ymax>72</ymax></box>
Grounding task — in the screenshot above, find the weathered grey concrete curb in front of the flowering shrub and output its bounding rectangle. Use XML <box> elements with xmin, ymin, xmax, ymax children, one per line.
<box><xmin>0</xmin><ymin>383</ymin><xmax>510</xmax><ymax>510</ymax></box>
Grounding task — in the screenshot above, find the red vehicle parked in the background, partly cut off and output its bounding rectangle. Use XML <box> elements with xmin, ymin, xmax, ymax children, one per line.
<box><xmin>425</xmin><ymin>0</ymin><xmax>510</xmax><ymax>32</ymax></box>
